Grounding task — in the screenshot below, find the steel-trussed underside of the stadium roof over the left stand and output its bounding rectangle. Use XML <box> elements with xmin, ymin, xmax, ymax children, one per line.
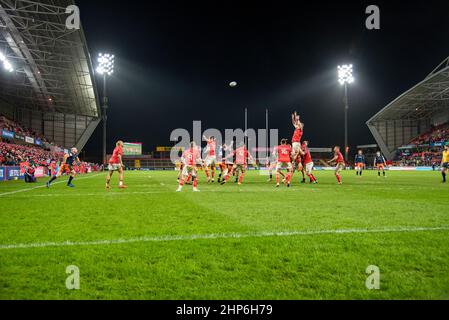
<box><xmin>0</xmin><ymin>0</ymin><xmax>100</xmax><ymax>117</ymax></box>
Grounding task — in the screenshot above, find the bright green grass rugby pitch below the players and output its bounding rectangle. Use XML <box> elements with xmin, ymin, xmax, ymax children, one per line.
<box><xmin>0</xmin><ymin>172</ymin><xmax>449</xmax><ymax>299</ymax></box>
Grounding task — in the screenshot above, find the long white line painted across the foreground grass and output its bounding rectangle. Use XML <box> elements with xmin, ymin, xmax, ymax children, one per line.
<box><xmin>0</xmin><ymin>226</ymin><xmax>449</xmax><ymax>250</ymax></box>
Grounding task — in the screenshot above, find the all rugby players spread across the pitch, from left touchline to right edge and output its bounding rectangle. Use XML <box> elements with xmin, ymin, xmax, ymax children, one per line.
<box><xmin>42</xmin><ymin>112</ymin><xmax>449</xmax><ymax>192</ymax></box>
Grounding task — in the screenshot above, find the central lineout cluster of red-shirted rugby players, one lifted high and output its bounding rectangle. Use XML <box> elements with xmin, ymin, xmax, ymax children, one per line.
<box><xmin>177</xmin><ymin>112</ymin><xmax>346</xmax><ymax>192</ymax></box>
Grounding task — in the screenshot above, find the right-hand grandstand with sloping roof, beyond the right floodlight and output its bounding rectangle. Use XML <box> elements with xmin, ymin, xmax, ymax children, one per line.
<box><xmin>366</xmin><ymin>57</ymin><xmax>449</xmax><ymax>163</ymax></box>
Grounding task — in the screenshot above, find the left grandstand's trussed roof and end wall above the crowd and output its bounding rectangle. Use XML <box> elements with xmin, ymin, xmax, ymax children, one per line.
<box><xmin>0</xmin><ymin>0</ymin><xmax>101</xmax><ymax>150</ymax></box>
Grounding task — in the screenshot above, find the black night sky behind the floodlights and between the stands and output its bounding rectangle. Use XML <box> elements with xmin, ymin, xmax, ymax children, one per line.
<box><xmin>77</xmin><ymin>0</ymin><xmax>449</xmax><ymax>160</ymax></box>
